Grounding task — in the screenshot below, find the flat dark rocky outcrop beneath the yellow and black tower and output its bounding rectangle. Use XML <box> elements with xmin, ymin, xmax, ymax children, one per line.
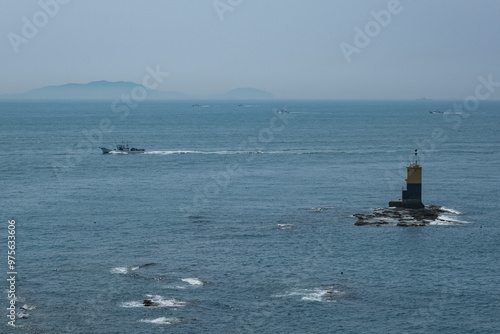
<box><xmin>353</xmin><ymin>205</ymin><xmax>449</xmax><ymax>226</ymax></box>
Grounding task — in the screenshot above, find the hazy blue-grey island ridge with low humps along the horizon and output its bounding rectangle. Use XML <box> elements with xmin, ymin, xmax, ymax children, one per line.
<box><xmin>0</xmin><ymin>80</ymin><xmax>274</xmax><ymax>100</ymax></box>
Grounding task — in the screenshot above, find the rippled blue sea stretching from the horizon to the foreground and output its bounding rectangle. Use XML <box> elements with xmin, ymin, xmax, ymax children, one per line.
<box><xmin>0</xmin><ymin>101</ymin><xmax>500</xmax><ymax>333</ymax></box>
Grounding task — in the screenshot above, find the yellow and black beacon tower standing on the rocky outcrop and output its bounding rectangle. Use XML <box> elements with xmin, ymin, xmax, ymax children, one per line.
<box><xmin>389</xmin><ymin>150</ymin><xmax>424</xmax><ymax>209</ymax></box>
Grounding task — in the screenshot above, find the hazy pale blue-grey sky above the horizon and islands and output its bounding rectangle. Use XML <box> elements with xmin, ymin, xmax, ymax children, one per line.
<box><xmin>0</xmin><ymin>0</ymin><xmax>500</xmax><ymax>99</ymax></box>
